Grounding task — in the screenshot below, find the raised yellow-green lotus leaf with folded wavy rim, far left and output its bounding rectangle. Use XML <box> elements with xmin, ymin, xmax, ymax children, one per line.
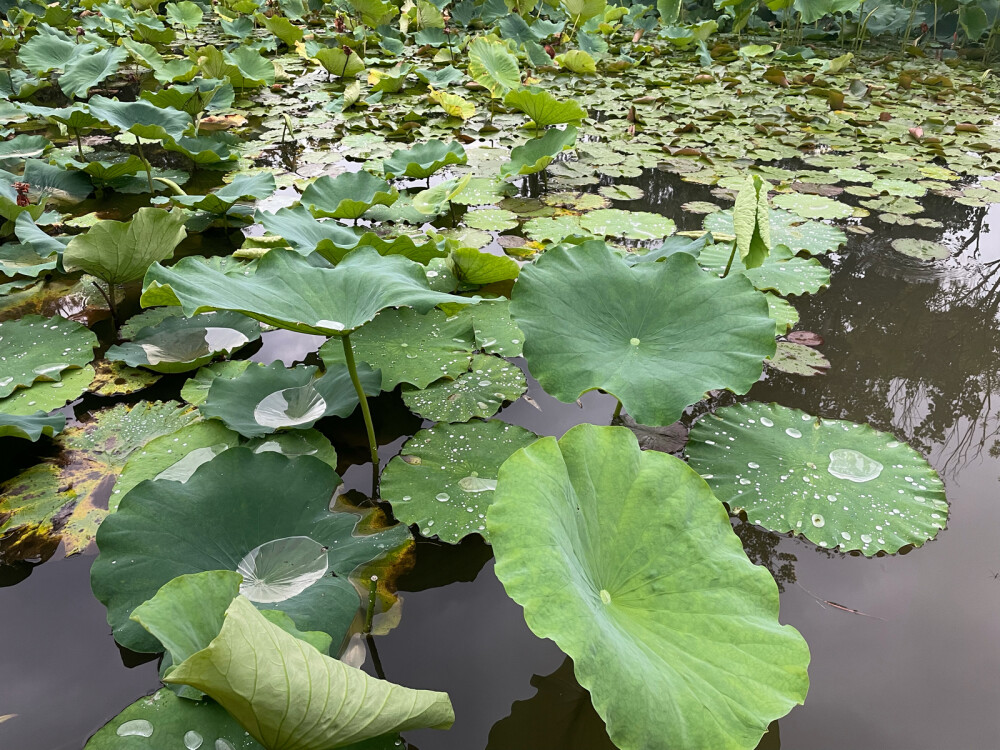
<box><xmin>63</xmin><ymin>208</ymin><xmax>187</xmax><ymax>284</ymax></box>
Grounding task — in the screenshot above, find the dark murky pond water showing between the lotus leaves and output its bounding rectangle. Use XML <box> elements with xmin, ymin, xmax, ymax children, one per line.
<box><xmin>0</xmin><ymin>171</ymin><xmax>1000</xmax><ymax>750</ymax></box>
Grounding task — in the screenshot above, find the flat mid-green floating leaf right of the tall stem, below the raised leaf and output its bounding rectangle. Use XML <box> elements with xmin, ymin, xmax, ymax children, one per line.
<box><xmin>319</xmin><ymin>309</ymin><xmax>476</xmax><ymax>390</ymax></box>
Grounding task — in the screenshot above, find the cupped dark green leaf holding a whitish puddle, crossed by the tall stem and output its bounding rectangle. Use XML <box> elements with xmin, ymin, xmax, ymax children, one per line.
<box><xmin>198</xmin><ymin>362</ymin><xmax>381</xmax><ymax>437</ymax></box>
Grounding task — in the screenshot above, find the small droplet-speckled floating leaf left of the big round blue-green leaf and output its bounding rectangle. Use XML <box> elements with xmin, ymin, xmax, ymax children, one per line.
<box><xmin>403</xmin><ymin>354</ymin><xmax>528</xmax><ymax>422</ymax></box>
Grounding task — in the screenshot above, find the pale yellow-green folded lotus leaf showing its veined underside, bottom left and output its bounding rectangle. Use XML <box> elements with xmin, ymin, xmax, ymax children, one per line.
<box><xmin>166</xmin><ymin>596</ymin><xmax>455</xmax><ymax>750</ymax></box>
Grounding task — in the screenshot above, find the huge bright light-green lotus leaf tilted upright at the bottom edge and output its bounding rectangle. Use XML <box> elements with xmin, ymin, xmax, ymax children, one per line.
<box><xmin>487</xmin><ymin>426</ymin><xmax>809</xmax><ymax>750</ymax></box>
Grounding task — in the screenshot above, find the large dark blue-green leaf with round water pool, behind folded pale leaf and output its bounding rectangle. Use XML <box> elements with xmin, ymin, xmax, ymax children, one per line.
<box><xmin>91</xmin><ymin>448</ymin><xmax>411</xmax><ymax>651</ymax></box>
